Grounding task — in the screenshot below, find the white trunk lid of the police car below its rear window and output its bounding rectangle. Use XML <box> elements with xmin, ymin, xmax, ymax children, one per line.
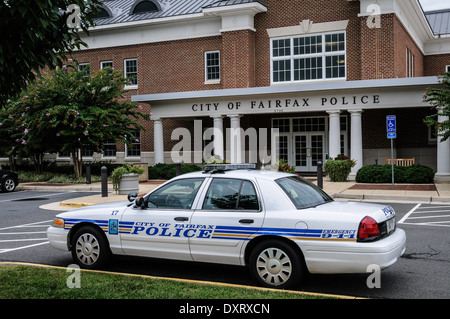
<box><xmin>309</xmin><ymin>201</ymin><xmax>395</xmax><ymax>223</ymax></box>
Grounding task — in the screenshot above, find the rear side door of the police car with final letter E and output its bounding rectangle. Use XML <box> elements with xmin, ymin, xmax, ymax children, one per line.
<box><xmin>189</xmin><ymin>177</ymin><xmax>264</xmax><ymax>265</ymax></box>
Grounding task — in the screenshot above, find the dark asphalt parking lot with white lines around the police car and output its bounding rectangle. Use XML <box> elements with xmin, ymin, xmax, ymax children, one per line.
<box><xmin>0</xmin><ymin>192</ymin><xmax>450</xmax><ymax>299</ymax></box>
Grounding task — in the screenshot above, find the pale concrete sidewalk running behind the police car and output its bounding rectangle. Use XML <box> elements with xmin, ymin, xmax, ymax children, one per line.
<box><xmin>18</xmin><ymin>180</ymin><xmax>450</xmax><ymax>211</ymax></box>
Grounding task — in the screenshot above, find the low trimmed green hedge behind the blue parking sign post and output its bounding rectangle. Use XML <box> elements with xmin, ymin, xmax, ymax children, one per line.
<box><xmin>356</xmin><ymin>165</ymin><xmax>434</xmax><ymax>184</ymax></box>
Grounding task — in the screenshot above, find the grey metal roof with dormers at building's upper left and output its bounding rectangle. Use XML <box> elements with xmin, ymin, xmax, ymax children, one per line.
<box><xmin>95</xmin><ymin>0</ymin><xmax>265</xmax><ymax>26</ymax></box>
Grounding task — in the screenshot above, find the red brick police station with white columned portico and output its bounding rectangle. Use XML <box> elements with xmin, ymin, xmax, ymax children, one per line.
<box><xmin>44</xmin><ymin>0</ymin><xmax>450</xmax><ymax>181</ymax></box>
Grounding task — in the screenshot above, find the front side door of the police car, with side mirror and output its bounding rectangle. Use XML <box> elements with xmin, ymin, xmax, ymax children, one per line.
<box><xmin>119</xmin><ymin>178</ymin><xmax>205</xmax><ymax>260</ymax></box>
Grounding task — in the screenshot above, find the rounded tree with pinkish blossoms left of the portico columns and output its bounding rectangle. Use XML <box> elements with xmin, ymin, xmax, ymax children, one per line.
<box><xmin>0</xmin><ymin>59</ymin><xmax>149</xmax><ymax>178</ymax></box>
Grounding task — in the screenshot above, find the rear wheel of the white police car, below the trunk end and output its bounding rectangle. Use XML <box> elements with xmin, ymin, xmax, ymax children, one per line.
<box><xmin>249</xmin><ymin>240</ymin><xmax>305</xmax><ymax>289</ymax></box>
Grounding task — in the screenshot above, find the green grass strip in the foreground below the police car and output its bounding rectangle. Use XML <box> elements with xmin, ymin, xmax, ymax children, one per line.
<box><xmin>0</xmin><ymin>265</ymin><xmax>338</xmax><ymax>299</ymax></box>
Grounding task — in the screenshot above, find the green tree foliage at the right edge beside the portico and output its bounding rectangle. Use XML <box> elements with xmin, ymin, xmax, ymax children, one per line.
<box><xmin>424</xmin><ymin>72</ymin><xmax>450</xmax><ymax>141</ymax></box>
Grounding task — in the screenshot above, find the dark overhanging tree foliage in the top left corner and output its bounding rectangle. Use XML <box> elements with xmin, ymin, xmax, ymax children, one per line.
<box><xmin>0</xmin><ymin>0</ymin><xmax>100</xmax><ymax>105</ymax></box>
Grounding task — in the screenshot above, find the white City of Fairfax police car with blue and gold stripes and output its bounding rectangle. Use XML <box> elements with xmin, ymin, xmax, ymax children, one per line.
<box><xmin>48</xmin><ymin>165</ymin><xmax>406</xmax><ymax>288</ymax></box>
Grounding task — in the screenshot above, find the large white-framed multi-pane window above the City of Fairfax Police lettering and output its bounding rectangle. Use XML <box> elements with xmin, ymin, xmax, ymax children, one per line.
<box><xmin>271</xmin><ymin>32</ymin><xmax>347</xmax><ymax>83</ymax></box>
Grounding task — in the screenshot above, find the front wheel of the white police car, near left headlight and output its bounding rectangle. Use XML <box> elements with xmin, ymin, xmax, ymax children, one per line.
<box><xmin>71</xmin><ymin>226</ymin><xmax>111</xmax><ymax>269</ymax></box>
